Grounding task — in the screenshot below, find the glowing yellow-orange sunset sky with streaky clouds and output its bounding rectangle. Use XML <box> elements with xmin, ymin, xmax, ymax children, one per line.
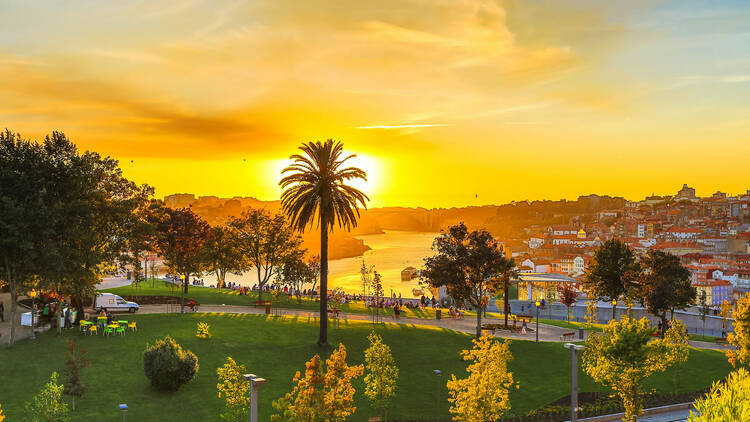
<box><xmin>0</xmin><ymin>0</ymin><xmax>750</xmax><ymax>207</ymax></box>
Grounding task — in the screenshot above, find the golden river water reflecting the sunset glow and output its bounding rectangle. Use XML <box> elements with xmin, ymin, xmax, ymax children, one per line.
<box><xmin>209</xmin><ymin>231</ymin><xmax>437</xmax><ymax>298</ymax></box>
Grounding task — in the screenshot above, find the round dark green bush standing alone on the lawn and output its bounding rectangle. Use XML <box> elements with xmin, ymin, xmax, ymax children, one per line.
<box><xmin>143</xmin><ymin>336</ymin><xmax>199</xmax><ymax>391</ymax></box>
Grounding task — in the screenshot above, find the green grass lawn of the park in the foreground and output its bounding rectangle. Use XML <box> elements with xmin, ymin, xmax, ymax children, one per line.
<box><xmin>0</xmin><ymin>312</ymin><xmax>730</xmax><ymax>422</ymax></box>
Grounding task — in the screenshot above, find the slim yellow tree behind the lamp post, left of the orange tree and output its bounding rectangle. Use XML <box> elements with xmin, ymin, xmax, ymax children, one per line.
<box><xmin>216</xmin><ymin>357</ymin><xmax>250</xmax><ymax>422</ymax></box>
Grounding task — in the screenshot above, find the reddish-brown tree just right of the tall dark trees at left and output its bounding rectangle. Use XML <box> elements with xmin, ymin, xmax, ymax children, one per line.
<box><xmin>151</xmin><ymin>204</ymin><xmax>211</xmax><ymax>313</ymax></box>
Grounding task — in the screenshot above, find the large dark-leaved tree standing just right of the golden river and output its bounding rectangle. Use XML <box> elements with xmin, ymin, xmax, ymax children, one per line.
<box><xmin>422</xmin><ymin>223</ymin><xmax>508</xmax><ymax>338</ymax></box>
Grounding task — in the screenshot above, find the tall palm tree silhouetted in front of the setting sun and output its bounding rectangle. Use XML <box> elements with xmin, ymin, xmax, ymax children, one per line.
<box><xmin>279</xmin><ymin>139</ymin><xmax>370</xmax><ymax>347</ymax></box>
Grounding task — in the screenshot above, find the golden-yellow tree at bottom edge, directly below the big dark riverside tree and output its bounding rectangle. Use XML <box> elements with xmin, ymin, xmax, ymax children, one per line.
<box><xmin>447</xmin><ymin>336</ymin><xmax>513</xmax><ymax>422</ymax></box>
